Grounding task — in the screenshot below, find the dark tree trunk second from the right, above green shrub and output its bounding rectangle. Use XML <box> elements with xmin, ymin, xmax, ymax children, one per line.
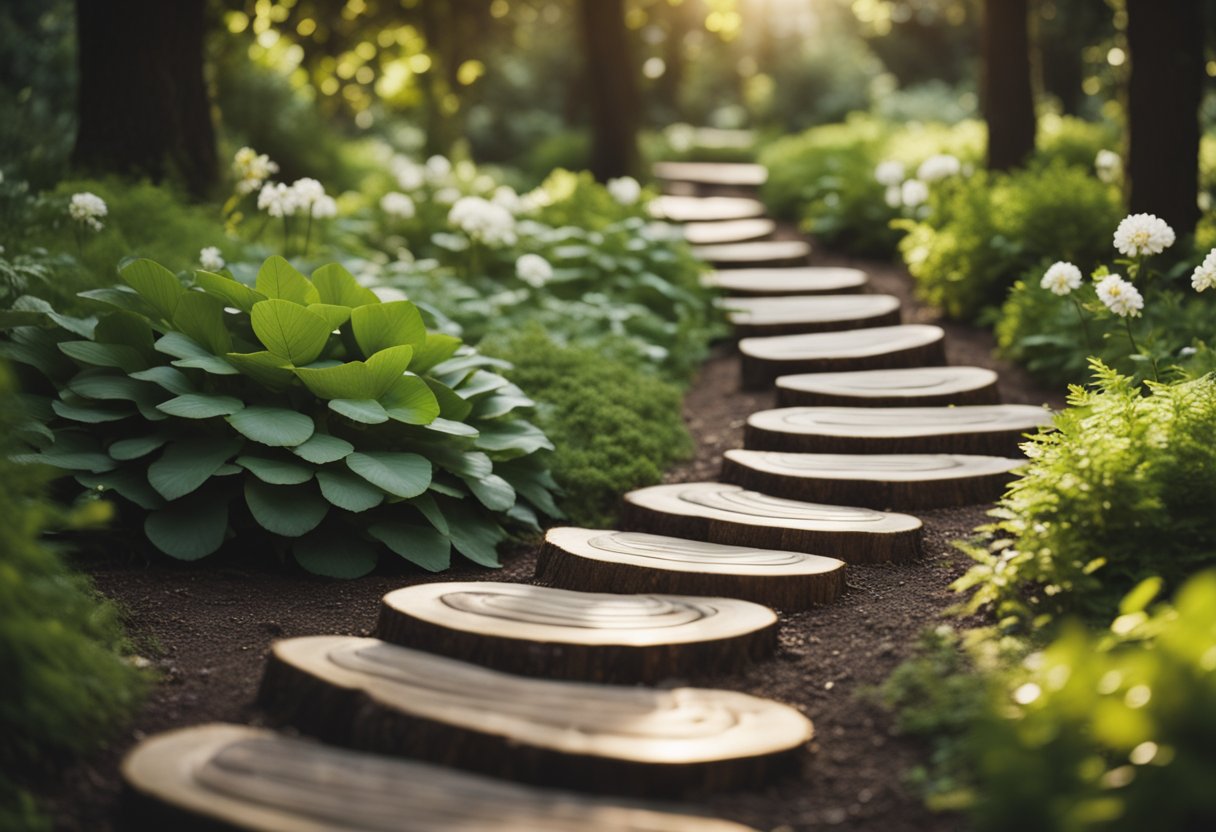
<box><xmin>981</xmin><ymin>0</ymin><xmax>1035</xmax><ymax>170</ymax></box>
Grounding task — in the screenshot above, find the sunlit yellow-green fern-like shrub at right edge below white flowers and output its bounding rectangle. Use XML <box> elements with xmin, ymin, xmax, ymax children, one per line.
<box><xmin>956</xmin><ymin>361</ymin><xmax>1216</xmax><ymax>623</ymax></box>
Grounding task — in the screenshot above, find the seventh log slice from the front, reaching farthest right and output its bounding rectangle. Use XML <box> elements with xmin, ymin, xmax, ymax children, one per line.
<box><xmin>743</xmin><ymin>405</ymin><xmax>1052</xmax><ymax>456</ymax></box>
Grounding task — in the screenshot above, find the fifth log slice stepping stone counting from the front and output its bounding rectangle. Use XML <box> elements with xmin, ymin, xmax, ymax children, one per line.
<box><xmin>621</xmin><ymin>483</ymin><xmax>922</xmax><ymax>563</ymax></box>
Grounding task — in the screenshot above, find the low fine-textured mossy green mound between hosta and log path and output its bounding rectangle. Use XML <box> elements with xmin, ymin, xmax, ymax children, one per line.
<box><xmin>483</xmin><ymin>326</ymin><xmax>693</xmax><ymax>528</ymax></box>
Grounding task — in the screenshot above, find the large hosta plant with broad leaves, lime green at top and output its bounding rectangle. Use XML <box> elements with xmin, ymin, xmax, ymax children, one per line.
<box><xmin>4</xmin><ymin>257</ymin><xmax>556</xmax><ymax>577</ymax></box>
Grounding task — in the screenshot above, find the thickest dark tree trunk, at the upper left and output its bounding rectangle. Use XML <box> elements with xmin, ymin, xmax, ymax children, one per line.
<box><xmin>72</xmin><ymin>0</ymin><xmax>219</xmax><ymax>196</ymax></box>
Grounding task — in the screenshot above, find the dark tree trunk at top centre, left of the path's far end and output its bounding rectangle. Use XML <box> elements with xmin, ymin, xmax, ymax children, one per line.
<box><xmin>579</xmin><ymin>0</ymin><xmax>640</xmax><ymax>181</ymax></box>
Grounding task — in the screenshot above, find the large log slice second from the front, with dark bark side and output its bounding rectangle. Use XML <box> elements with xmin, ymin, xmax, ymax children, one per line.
<box><xmin>259</xmin><ymin>636</ymin><xmax>812</xmax><ymax>796</ymax></box>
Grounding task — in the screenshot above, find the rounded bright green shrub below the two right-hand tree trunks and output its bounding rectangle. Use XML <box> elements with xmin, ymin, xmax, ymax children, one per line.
<box><xmin>900</xmin><ymin>162</ymin><xmax>1120</xmax><ymax>320</ymax></box>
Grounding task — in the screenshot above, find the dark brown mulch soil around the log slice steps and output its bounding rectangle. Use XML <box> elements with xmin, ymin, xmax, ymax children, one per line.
<box><xmin>45</xmin><ymin>251</ymin><xmax>1062</xmax><ymax>832</ymax></box>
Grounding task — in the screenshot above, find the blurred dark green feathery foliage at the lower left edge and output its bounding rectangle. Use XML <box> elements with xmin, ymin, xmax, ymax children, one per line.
<box><xmin>0</xmin><ymin>362</ymin><xmax>146</xmax><ymax>828</ymax></box>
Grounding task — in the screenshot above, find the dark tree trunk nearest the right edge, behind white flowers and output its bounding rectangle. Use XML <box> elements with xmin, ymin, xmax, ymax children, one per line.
<box><xmin>1127</xmin><ymin>0</ymin><xmax>1204</xmax><ymax>235</ymax></box>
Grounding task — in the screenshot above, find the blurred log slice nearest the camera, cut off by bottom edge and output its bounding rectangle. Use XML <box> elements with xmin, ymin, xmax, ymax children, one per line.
<box><xmin>123</xmin><ymin>724</ymin><xmax>748</xmax><ymax>832</ymax></box>
